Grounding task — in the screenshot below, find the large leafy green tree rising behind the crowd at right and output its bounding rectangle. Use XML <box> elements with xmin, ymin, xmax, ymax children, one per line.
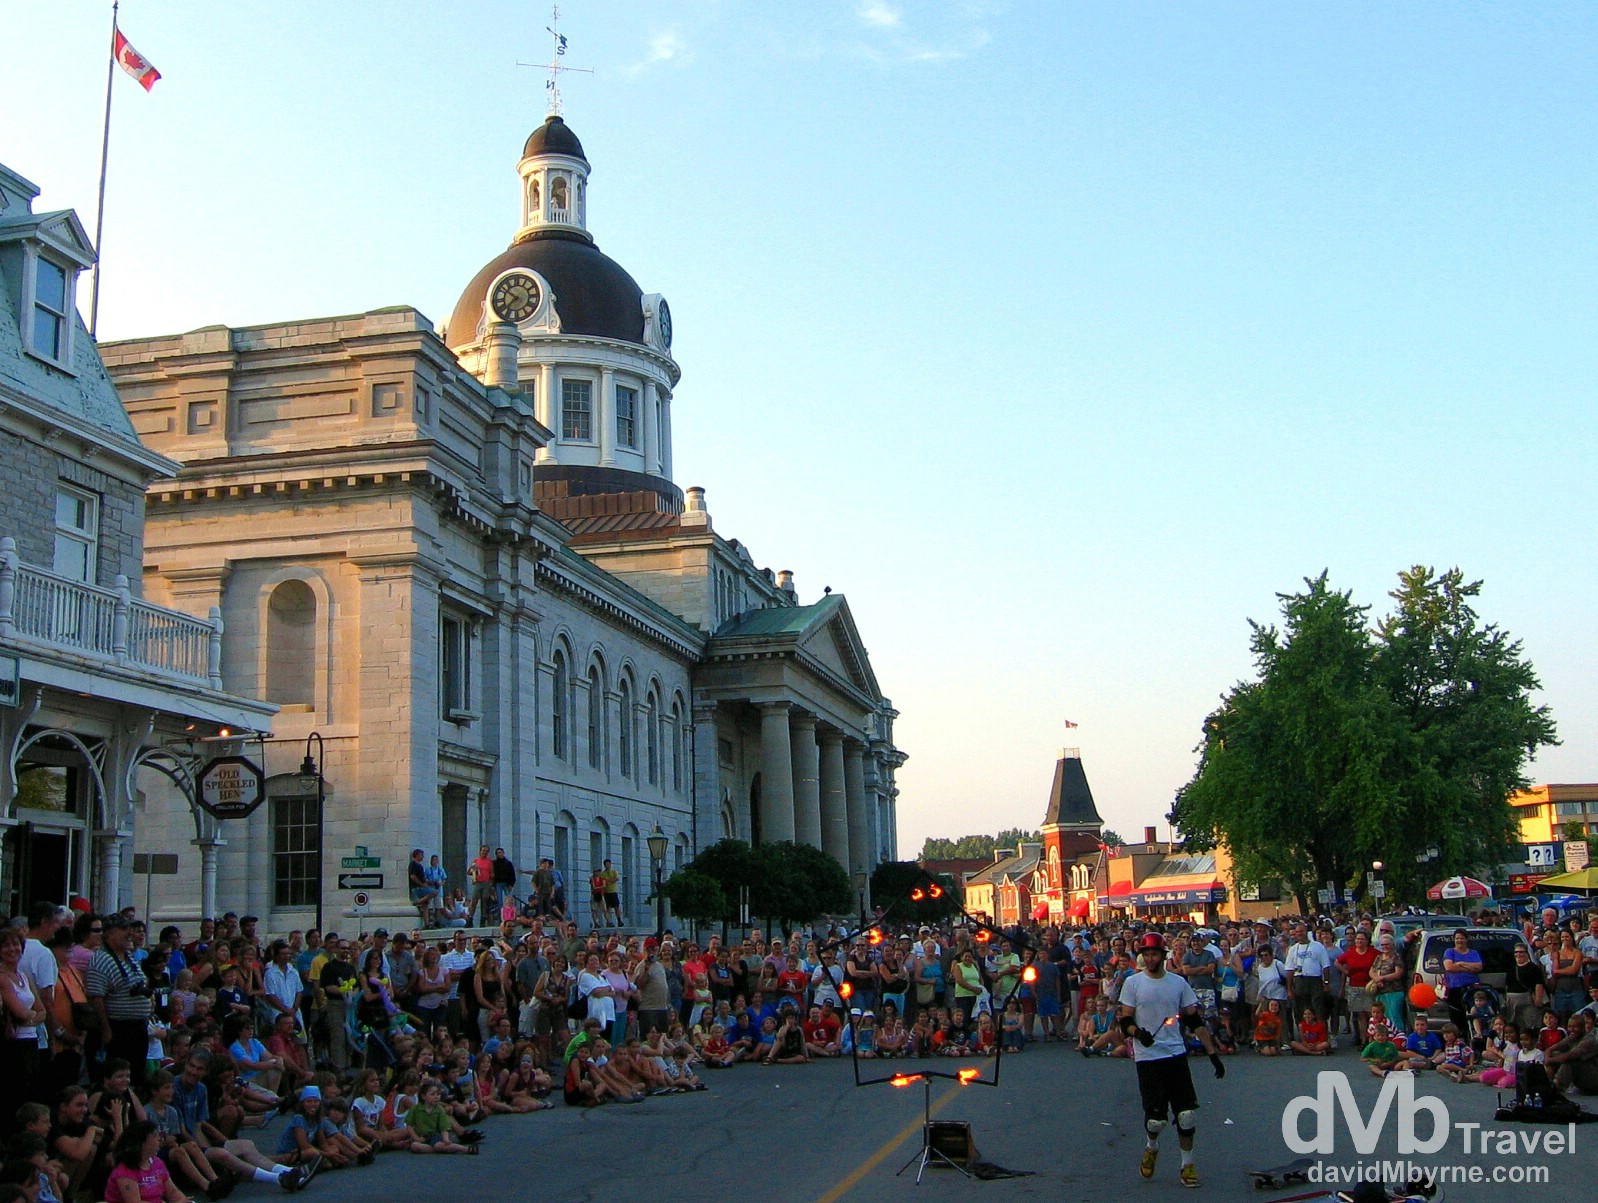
<box><xmin>1171</xmin><ymin>567</ymin><xmax>1555</xmax><ymax>909</ymax></box>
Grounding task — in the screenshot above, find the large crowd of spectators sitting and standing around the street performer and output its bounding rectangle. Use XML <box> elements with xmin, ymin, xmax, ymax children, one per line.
<box><xmin>0</xmin><ymin>875</ymin><xmax>1598</xmax><ymax>1203</ymax></box>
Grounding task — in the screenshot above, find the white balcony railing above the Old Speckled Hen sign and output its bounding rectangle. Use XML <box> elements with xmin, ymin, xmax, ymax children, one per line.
<box><xmin>0</xmin><ymin>537</ymin><xmax>222</xmax><ymax>689</ymax></box>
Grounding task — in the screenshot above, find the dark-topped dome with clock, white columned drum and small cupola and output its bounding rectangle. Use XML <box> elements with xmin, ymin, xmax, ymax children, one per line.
<box><xmin>444</xmin><ymin>113</ymin><xmax>682</xmax><ymax>513</ymax></box>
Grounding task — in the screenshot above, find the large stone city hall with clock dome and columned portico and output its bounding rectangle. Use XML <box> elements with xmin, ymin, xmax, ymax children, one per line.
<box><xmin>101</xmin><ymin>117</ymin><xmax>904</xmax><ymax>930</ymax></box>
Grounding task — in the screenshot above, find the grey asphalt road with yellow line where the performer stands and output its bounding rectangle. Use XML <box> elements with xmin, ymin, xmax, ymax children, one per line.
<box><xmin>246</xmin><ymin>1045</ymin><xmax>1598</xmax><ymax>1203</ymax></box>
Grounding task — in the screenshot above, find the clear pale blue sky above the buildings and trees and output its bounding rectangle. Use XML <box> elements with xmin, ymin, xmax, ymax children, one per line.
<box><xmin>9</xmin><ymin>0</ymin><xmax>1598</xmax><ymax>852</ymax></box>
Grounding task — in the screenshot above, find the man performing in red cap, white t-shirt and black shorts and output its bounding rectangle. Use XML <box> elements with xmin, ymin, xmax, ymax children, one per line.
<box><xmin>1115</xmin><ymin>931</ymin><xmax>1226</xmax><ymax>1187</ymax></box>
